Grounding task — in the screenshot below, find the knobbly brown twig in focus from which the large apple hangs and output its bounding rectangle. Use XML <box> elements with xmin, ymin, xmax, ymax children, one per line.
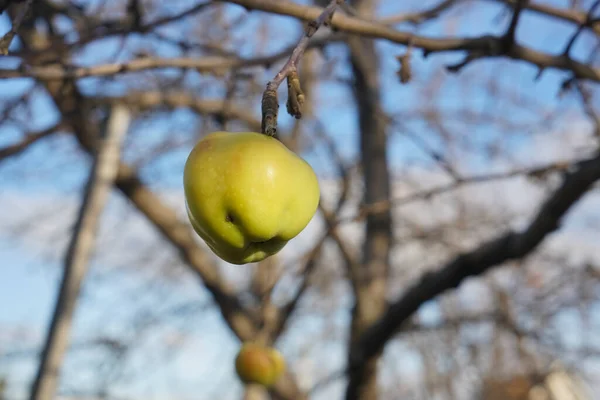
<box><xmin>262</xmin><ymin>0</ymin><xmax>344</xmax><ymax>137</ymax></box>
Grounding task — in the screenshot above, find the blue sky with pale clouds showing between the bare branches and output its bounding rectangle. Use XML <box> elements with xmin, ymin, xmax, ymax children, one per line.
<box><xmin>0</xmin><ymin>1</ymin><xmax>600</xmax><ymax>400</ymax></box>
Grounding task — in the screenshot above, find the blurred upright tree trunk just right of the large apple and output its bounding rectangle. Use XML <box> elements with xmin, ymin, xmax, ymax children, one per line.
<box><xmin>346</xmin><ymin>0</ymin><xmax>392</xmax><ymax>400</ymax></box>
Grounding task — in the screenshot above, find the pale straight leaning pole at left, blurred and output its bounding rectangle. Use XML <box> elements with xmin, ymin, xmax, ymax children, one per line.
<box><xmin>30</xmin><ymin>106</ymin><xmax>129</xmax><ymax>400</ymax></box>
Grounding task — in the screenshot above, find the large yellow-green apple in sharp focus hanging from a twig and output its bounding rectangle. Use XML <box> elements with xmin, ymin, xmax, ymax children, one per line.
<box><xmin>183</xmin><ymin>132</ymin><xmax>320</xmax><ymax>265</ymax></box>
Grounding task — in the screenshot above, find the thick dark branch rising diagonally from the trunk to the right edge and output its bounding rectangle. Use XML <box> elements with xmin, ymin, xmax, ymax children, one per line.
<box><xmin>349</xmin><ymin>152</ymin><xmax>600</xmax><ymax>396</ymax></box>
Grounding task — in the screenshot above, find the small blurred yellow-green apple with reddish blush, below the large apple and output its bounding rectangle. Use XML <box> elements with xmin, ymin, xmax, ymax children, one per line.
<box><xmin>235</xmin><ymin>343</ymin><xmax>285</xmax><ymax>387</ymax></box>
